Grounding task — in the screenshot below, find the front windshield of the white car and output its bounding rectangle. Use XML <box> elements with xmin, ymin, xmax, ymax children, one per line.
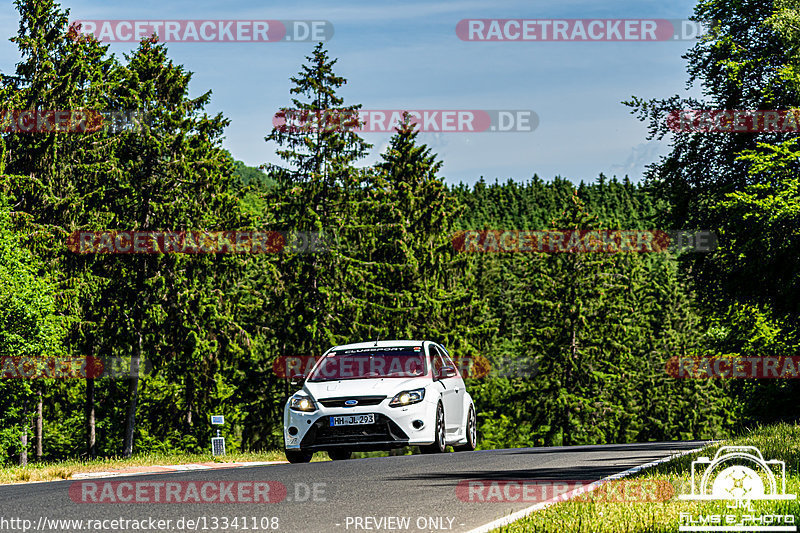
<box><xmin>308</xmin><ymin>346</ymin><xmax>427</xmax><ymax>381</ymax></box>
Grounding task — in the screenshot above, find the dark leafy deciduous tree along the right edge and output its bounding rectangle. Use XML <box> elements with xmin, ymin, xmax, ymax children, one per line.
<box><xmin>629</xmin><ymin>0</ymin><xmax>800</xmax><ymax>425</ymax></box>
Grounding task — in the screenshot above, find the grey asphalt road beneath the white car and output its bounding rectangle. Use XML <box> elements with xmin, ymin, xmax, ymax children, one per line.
<box><xmin>0</xmin><ymin>442</ymin><xmax>703</xmax><ymax>532</ymax></box>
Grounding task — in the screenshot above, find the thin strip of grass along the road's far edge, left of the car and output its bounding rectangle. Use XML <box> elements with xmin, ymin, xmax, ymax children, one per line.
<box><xmin>0</xmin><ymin>450</ymin><xmax>316</xmax><ymax>484</ymax></box>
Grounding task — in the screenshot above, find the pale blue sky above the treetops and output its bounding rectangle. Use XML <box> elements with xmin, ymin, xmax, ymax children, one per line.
<box><xmin>0</xmin><ymin>0</ymin><xmax>697</xmax><ymax>183</ymax></box>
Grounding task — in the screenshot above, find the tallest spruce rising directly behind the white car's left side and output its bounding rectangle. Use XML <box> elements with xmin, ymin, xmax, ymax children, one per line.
<box><xmin>265</xmin><ymin>43</ymin><xmax>371</xmax><ymax>362</ymax></box>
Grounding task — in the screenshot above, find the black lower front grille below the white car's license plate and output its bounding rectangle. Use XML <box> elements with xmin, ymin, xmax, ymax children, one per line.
<box><xmin>300</xmin><ymin>413</ymin><xmax>408</xmax><ymax>448</ymax></box>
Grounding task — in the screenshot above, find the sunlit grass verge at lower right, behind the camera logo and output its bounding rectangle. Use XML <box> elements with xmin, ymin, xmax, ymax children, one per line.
<box><xmin>495</xmin><ymin>424</ymin><xmax>800</xmax><ymax>533</ymax></box>
